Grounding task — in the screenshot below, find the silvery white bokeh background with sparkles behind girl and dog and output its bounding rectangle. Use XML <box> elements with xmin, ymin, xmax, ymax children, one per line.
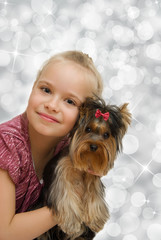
<box><xmin>0</xmin><ymin>0</ymin><xmax>161</xmax><ymax>240</ymax></box>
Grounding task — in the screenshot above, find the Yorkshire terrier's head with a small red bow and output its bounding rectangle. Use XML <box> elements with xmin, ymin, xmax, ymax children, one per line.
<box><xmin>70</xmin><ymin>98</ymin><xmax>131</xmax><ymax>176</ymax></box>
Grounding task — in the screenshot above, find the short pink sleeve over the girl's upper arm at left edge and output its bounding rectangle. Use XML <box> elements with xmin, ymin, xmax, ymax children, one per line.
<box><xmin>0</xmin><ymin>134</ymin><xmax>20</xmax><ymax>184</ymax></box>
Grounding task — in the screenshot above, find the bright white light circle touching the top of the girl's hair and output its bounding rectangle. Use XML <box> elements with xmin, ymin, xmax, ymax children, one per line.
<box><xmin>76</xmin><ymin>38</ymin><xmax>97</xmax><ymax>61</ymax></box>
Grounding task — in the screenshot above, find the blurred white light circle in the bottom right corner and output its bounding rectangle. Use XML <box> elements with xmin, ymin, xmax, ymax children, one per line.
<box><xmin>147</xmin><ymin>223</ymin><xmax>161</xmax><ymax>240</ymax></box>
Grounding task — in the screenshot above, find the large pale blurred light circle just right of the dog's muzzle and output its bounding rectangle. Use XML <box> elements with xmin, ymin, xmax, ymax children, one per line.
<box><xmin>123</xmin><ymin>134</ymin><xmax>139</xmax><ymax>154</ymax></box>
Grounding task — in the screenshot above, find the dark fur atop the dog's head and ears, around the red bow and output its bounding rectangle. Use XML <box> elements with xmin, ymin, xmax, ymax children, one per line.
<box><xmin>79</xmin><ymin>96</ymin><xmax>131</xmax><ymax>151</ymax></box>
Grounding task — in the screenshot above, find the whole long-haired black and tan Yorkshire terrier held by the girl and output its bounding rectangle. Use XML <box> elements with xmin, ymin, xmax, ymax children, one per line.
<box><xmin>38</xmin><ymin>98</ymin><xmax>131</xmax><ymax>240</ymax></box>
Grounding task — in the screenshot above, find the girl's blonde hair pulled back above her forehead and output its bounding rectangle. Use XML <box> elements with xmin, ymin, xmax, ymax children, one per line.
<box><xmin>35</xmin><ymin>51</ymin><xmax>103</xmax><ymax>96</ymax></box>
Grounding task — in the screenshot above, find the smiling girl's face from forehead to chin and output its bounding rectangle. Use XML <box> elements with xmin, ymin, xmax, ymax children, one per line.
<box><xmin>27</xmin><ymin>61</ymin><xmax>95</xmax><ymax>137</ymax></box>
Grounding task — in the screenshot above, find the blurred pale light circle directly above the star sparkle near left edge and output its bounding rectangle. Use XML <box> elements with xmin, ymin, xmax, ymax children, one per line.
<box><xmin>13</xmin><ymin>31</ymin><xmax>30</xmax><ymax>50</ymax></box>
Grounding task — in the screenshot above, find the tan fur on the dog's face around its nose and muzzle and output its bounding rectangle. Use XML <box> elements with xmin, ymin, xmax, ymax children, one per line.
<box><xmin>70</xmin><ymin>119</ymin><xmax>116</xmax><ymax>176</ymax></box>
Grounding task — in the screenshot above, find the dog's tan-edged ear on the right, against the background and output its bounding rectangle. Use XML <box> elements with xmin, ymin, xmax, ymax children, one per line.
<box><xmin>120</xmin><ymin>103</ymin><xmax>132</xmax><ymax>137</ymax></box>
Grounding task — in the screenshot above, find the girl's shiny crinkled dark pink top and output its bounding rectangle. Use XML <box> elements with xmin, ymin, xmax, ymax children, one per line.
<box><xmin>0</xmin><ymin>113</ymin><xmax>69</xmax><ymax>213</ymax></box>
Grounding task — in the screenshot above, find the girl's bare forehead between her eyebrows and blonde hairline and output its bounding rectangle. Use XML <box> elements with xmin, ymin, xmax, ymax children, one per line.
<box><xmin>36</xmin><ymin>62</ymin><xmax>96</xmax><ymax>102</ymax></box>
